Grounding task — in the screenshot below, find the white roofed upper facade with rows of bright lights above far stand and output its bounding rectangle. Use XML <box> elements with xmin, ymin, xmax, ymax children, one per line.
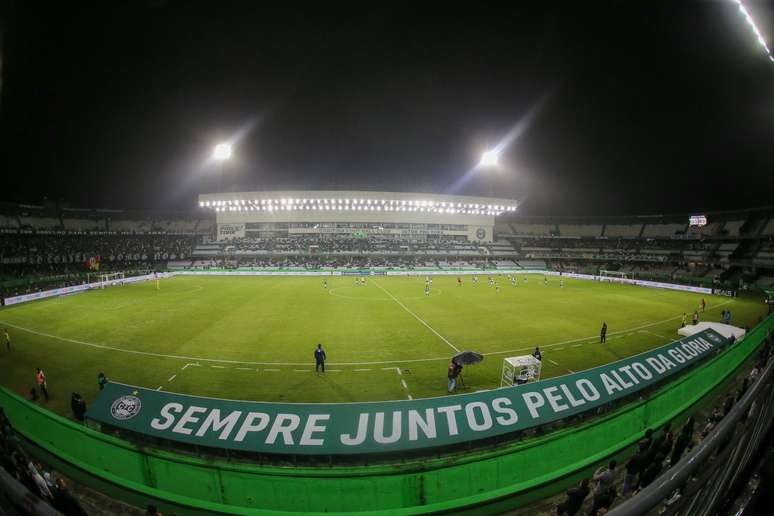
<box><xmin>199</xmin><ymin>191</ymin><xmax>517</xmax><ymax>242</ymax></box>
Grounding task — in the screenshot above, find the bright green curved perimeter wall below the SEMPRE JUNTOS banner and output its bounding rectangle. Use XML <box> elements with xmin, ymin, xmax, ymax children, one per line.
<box><xmin>0</xmin><ymin>317</ymin><xmax>774</xmax><ymax>514</ymax></box>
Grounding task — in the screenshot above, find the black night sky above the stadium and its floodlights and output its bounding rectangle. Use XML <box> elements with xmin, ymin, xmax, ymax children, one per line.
<box><xmin>0</xmin><ymin>0</ymin><xmax>774</xmax><ymax>215</ymax></box>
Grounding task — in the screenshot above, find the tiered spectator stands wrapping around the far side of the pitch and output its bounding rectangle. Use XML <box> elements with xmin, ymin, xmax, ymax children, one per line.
<box><xmin>0</xmin><ymin>204</ymin><xmax>774</xmax><ymax>295</ymax></box>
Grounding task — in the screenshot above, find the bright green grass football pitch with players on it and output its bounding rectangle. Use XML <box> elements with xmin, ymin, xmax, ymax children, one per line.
<box><xmin>0</xmin><ymin>275</ymin><xmax>765</xmax><ymax>414</ymax></box>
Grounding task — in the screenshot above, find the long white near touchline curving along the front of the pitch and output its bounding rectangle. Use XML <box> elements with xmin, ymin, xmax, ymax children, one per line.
<box><xmin>0</xmin><ymin>301</ymin><xmax>733</xmax><ymax>371</ymax></box>
